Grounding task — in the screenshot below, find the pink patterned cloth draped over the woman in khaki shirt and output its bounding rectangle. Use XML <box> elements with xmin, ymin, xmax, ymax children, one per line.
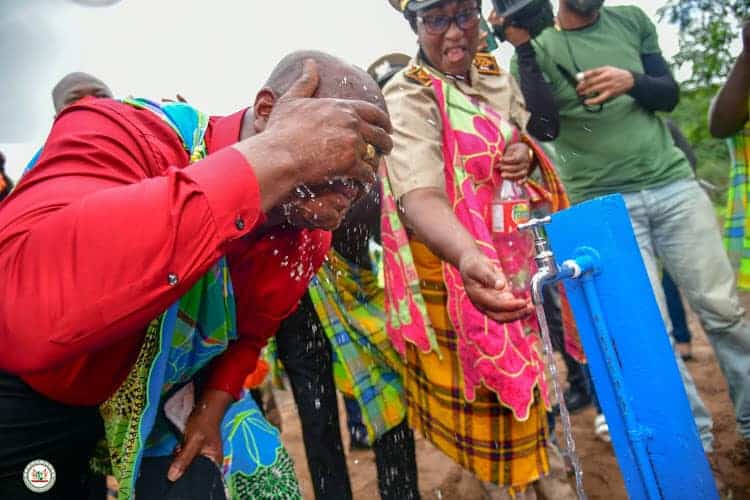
<box><xmin>383</xmin><ymin>72</ymin><xmax>581</xmax><ymax>420</ymax></box>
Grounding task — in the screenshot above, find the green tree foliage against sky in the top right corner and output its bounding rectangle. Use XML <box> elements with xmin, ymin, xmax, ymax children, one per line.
<box><xmin>658</xmin><ymin>0</ymin><xmax>750</xmax><ymax>88</ymax></box>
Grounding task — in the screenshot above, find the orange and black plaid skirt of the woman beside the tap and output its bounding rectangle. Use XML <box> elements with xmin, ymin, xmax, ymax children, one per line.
<box><xmin>403</xmin><ymin>240</ymin><xmax>549</xmax><ymax>490</ymax></box>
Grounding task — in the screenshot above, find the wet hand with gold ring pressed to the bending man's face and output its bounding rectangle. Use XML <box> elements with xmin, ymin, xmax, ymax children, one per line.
<box><xmin>260</xmin><ymin>60</ymin><xmax>393</xmax><ymax>190</ymax></box>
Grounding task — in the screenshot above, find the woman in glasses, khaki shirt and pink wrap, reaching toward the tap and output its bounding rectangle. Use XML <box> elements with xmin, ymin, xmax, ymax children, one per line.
<box><xmin>382</xmin><ymin>0</ymin><xmax>572</xmax><ymax>499</ymax></box>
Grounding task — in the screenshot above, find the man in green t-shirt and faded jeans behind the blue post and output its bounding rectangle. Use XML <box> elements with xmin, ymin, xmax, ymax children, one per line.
<box><xmin>514</xmin><ymin>0</ymin><xmax>750</xmax><ymax>451</ymax></box>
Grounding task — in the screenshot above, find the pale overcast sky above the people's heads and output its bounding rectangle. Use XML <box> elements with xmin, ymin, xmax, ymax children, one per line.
<box><xmin>0</xmin><ymin>0</ymin><xmax>692</xmax><ymax>178</ymax></box>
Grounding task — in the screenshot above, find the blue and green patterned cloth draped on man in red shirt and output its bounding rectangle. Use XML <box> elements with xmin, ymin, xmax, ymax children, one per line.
<box><xmin>94</xmin><ymin>99</ymin><xmax>301</xmax><ymax>499</ymax></box>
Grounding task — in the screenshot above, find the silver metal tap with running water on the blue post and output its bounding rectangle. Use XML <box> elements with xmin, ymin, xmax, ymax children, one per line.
<box><xmin>518</xmin><ymin>215</ymin><xmax>581</xmax><ymax>305</ymax></box>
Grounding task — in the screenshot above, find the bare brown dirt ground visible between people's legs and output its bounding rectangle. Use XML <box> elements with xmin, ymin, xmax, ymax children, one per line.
<box><xmin>276</xmin><ymin>294</ymin><xmax>750</xmax><ymax>500</ymax></box>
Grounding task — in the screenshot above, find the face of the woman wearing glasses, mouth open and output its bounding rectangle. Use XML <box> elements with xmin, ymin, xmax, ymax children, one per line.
<box><xmin>417</xmin><ymin>0</ymin><xmax>480</xmax><ymax>75</ymax></box>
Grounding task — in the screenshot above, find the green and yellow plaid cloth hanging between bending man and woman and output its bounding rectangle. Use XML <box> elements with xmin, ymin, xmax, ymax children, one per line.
<box><xmin>309</xmin><ymin>249</ymin><xmax>406</xmax><ymax>444</ymax></box>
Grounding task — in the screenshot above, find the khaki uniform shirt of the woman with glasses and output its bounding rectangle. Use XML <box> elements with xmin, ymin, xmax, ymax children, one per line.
<box><xmin>383</xmin><ymin>54</ymin><xmax>530</xmax><ymax>200</ymax></box>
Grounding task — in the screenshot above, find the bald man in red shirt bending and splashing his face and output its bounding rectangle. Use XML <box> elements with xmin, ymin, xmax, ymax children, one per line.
<box><xmin>0</xmin><ymin>53</ymin><xmax>391</xmax><ymax>498</ymax></box>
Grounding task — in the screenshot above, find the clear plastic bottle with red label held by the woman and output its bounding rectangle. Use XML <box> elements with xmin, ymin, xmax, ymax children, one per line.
<box><xmin>492</xmin><ymin>179</ymin><xmax>533</xmax><ymax>298</ymax></box>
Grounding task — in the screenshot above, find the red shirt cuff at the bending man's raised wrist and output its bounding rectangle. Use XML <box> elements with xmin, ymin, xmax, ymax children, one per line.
<box><xmin>185</xmin><ymin>147</ymin><xmax>265</xmax><ymax>240</ymax></box>
